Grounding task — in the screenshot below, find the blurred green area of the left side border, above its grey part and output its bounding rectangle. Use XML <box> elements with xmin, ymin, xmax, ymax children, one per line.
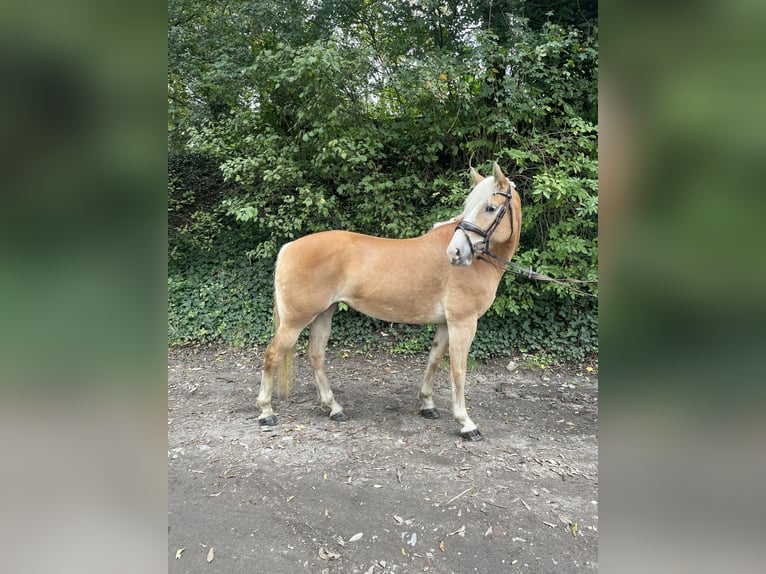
<box><xmin>0</xmin><ymin>0</ymin><xmax>167</xmax><ymax>394</ymax></box>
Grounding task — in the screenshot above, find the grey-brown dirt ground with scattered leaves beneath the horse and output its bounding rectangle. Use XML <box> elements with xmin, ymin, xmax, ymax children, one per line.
<box><xmin>168</xmin><ymin>349</ymin><xmax>598</xmax><ymax>574</ymax></box>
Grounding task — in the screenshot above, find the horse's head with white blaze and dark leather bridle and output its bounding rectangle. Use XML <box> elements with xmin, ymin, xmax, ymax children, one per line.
<box><xmin>447</xmin><ymin>163</ymin><xmax>515</xmax><ymax>265</ymax></box>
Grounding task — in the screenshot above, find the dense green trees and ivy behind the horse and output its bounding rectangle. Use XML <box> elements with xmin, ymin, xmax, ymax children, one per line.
<box><xmin>168</xmin><ymin>0</ymin><xmax>598</xmax><ymax>359</ymax></box>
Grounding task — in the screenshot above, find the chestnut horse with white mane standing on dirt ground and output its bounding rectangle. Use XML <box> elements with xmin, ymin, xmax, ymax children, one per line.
<box><xmin>256</xmin><ymin>163</ymin><xmax>521</xmax><ymax>441</ymax></box>
